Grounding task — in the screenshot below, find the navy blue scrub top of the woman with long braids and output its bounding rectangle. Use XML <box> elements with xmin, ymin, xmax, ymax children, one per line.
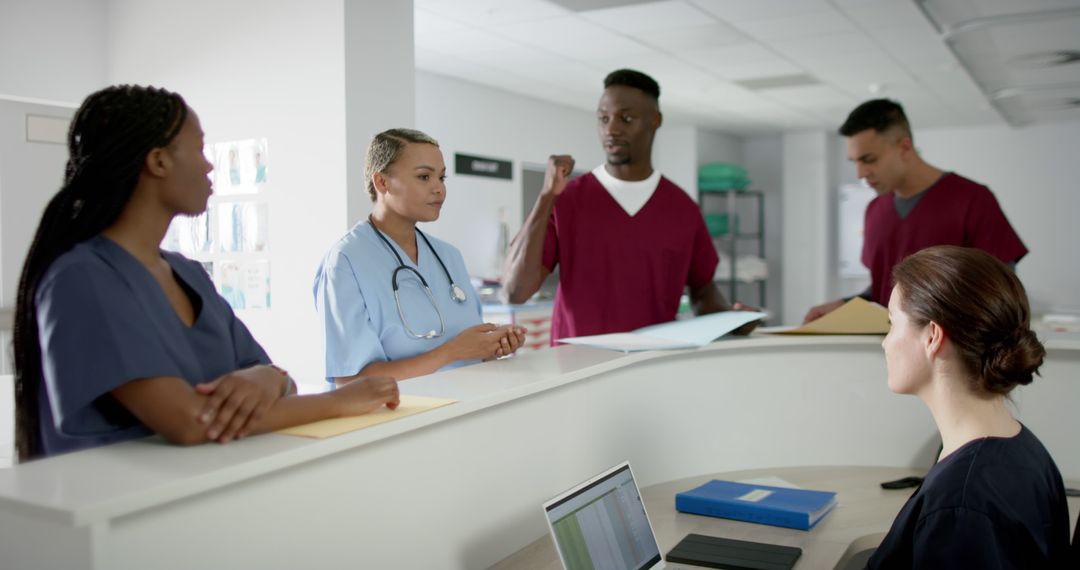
<box><xmin>35</xmin><ymin>235</ymin><xmax>270</xmax><ymax>456</ymax></box>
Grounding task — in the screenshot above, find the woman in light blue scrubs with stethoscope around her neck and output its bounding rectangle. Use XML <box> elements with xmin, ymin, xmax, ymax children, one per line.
<box><xmin>314</xmin><ymin>128</ymin><xmax>525</xmax><ymax>382</ymax></box>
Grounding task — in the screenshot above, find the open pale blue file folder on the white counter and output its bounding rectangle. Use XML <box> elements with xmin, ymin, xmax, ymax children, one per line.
<box><xmin>558</xmin><ymin>311</ymin><xmax>769</xmax><ymax>352</ymax></box>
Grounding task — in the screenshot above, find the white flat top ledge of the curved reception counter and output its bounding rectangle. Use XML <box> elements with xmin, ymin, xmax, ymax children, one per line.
<box><xmin>0</xmin><ymin>336</ymin><xmax>1080</xmax><ymax>526</ymax></box>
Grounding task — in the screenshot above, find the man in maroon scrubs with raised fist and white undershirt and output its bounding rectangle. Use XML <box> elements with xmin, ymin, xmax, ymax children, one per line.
<box><xmin>502</xmin><ymin>69</ymin><xmax>754</xmax><ymax>344</ymax></box>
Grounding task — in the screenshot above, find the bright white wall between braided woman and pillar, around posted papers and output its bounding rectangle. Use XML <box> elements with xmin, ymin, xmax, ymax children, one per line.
<box><xmin>107</xmin><ymin>0</ymin><xmax>346</xmax><ymax>380</ymax></box>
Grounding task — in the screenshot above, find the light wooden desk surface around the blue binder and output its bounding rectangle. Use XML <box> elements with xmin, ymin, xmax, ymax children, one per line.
<box><xmin>491</xmin><ymin>466</ymin><xmax>1080</xmax><ymax>570</ymax></box>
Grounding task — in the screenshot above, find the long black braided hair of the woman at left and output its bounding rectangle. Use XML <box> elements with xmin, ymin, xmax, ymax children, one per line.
<box><xmin>12</xmin><ymin>85</ymin><xmax>188</xmax><ymax>461</ymax></box>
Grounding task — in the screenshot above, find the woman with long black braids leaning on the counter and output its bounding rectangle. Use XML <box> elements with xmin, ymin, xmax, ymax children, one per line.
<box><xmin>14</xmin><ymin>85</ymin><xmax>399</xmax><ymax>461</ymax></box>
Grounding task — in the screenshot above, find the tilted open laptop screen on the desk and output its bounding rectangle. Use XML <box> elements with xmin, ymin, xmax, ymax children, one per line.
<box><xmin>543</xmin><ymin>463</ymin><xmax>661</xmax><ymax>570</ymax></box>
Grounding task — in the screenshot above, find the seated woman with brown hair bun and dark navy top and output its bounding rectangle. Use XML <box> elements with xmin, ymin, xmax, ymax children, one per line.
<box><xmin>867</xmin><ymin>246</ymin><xmax>1069</xmax><ymax>569</ymax></box>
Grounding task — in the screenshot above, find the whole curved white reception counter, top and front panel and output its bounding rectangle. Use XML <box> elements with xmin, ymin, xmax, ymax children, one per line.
<box><xmin>0</xmin><ymin>337</ymin><xmax>1080</xmax><ymax>569</ymax></box>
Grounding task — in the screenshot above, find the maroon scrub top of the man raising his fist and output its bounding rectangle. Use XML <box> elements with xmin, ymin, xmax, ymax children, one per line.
<box><xmin>543</xmin><ymin>173</ymin><xmax>718</xmax><ymax>344</ymax></box>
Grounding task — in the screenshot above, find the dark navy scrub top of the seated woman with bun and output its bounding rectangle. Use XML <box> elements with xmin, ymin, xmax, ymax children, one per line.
<box><xmin>867</xmin><ymin>426</ymin><xmax>1069</xmax><ymax>570</ymax></box>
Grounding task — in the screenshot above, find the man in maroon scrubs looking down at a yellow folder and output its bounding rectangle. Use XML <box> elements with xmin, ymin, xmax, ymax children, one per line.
<box><xmin>805</xmin><ymin>99</ymin><xmax>1027</xmax><ymax>322</ymax></box>
